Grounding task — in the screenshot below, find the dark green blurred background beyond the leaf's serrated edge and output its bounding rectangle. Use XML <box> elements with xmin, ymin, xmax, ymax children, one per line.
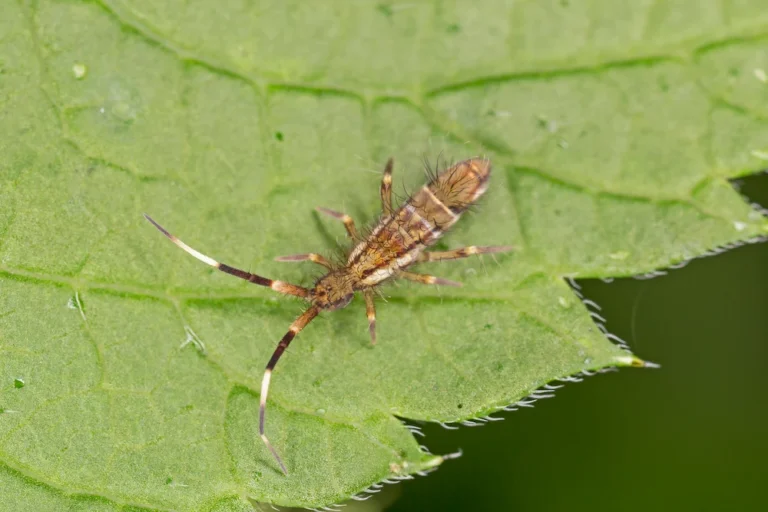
<box><xmin>387</xmin><ymin>174</ymin><xmax>768</xmax><ymax>512</ymax></box>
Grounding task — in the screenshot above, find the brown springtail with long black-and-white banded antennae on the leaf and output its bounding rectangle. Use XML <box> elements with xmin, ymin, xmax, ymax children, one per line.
<box><xmin>144</xmin><ymin>158</ymin><xmax>512</xmax><ymax>475</ymax></box>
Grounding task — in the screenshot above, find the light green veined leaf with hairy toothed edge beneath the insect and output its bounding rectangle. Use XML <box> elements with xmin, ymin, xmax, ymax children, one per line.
<box><xmin>0</xmin><ymin>0</ymin><xmax>768</xmax><ymax>511</ymax></box>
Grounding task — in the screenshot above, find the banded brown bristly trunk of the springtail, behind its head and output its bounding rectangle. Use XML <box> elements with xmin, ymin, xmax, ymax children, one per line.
<box><xmin>348</xmin><ymin>158</ymin><xmax>491</xmax><ymax>286</ymax></box>
